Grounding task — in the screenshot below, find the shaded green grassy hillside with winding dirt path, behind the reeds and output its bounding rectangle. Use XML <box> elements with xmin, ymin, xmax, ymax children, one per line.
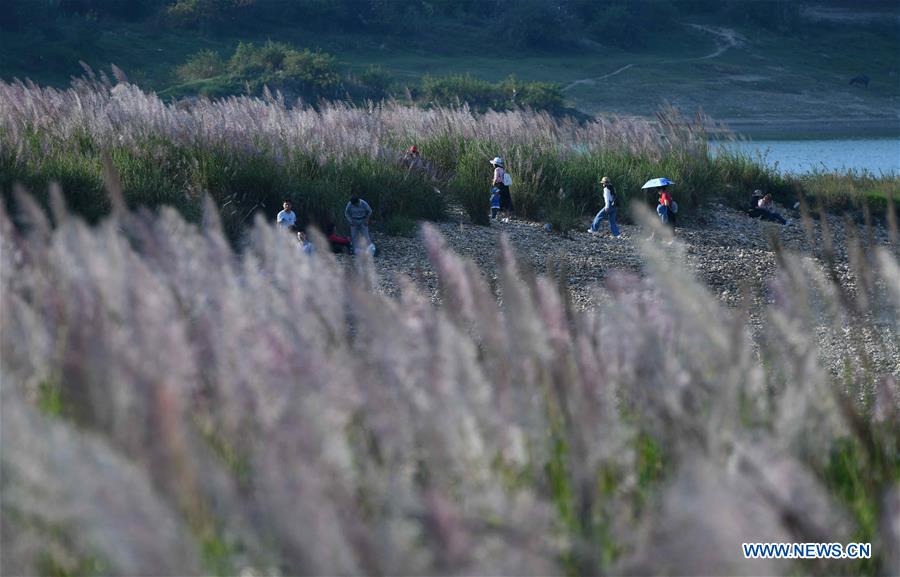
<box><xmin>0</xmin><ymin>2</ymin><xmax>900</xmax><ymax>134</ymax></box>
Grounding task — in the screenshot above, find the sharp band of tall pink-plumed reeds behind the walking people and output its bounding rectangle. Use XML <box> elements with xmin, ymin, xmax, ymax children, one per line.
<box><xmin>0</xmin><ymin>70</ymin><xmax>816</xmax><ymax>238</ymax></box>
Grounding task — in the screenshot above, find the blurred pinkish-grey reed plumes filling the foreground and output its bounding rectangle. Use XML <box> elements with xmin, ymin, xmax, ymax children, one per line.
<box><xmin>0</xmin><ymin>190</ymin><xmax>900</xmax><ymax>575</ymax></box>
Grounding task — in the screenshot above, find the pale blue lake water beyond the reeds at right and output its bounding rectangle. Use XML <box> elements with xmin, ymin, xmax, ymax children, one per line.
<box><xmin>710</xmin><ymin>138</ymin><xmax>900</xmax><ymax>176</ymax></box>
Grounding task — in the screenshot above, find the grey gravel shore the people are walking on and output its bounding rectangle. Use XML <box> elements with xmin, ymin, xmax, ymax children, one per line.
<box><xmin>339</xmin><ymin>204</ymin><xmax>900</xmax><ymax>374</ymax></box>
